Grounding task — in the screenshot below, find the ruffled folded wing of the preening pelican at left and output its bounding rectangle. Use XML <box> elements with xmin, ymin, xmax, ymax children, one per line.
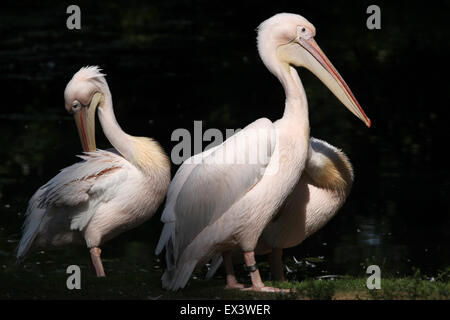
<box><xmin>17</xmin><ymin>149</ymin><xmax>130</xmax><ymax>259</ymax></box>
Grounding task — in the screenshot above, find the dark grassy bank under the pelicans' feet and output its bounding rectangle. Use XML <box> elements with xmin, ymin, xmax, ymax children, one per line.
<box><xmin>0</xmin><ymin>269</ymin><xmax>450</xmax><ymax>300</ymax></box>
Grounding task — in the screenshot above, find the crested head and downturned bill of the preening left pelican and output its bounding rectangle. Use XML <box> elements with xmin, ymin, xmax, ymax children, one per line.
<box><xmin>64</xmin><ymin>66</ymin><xmax>106</xmax><ymax>151</ymax></box>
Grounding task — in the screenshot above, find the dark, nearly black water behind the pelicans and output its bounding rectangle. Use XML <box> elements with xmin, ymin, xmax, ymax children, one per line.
<box><xmin>0</xmin><ymin>1</ymin><xmax>450</xmax><ymax>284</ymax></box>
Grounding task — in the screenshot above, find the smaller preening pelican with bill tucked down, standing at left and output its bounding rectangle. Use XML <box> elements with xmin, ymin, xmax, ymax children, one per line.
<box><xmin>17</xmin><ymin>66</ymin><xmax>170</xmax><ymax>277</ymax></box>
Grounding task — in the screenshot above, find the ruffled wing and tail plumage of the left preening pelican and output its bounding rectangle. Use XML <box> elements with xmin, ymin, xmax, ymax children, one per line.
<box><xmin>17</xmin><ymin>150</ymin><xmax>126</xmax><ymax>258</ymax></box>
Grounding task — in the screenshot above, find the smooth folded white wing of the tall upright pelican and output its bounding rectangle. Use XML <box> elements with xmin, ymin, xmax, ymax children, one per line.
<box><xmin>162</xmin><ymin>119</ymin><xmax>276</xmax><ymax>261</ymax></box>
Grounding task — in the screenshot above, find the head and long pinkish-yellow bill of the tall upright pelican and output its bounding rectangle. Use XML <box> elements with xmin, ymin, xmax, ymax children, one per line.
<box><xmin>258</xmin><ymin>13</ymin><xmax>371</xmax><ymax>127</ymax></box>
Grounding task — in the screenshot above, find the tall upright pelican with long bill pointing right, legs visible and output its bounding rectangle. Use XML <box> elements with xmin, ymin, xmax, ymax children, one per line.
<box><xmin>156</xmin><ymin>13</ymin><xmax>370</xmax><ymax>292</ymax></box>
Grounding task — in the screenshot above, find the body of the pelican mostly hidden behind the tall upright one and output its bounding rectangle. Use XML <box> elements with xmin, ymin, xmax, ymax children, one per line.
<box><xmin>256</xmin><ymin>138</ymin><xmax>353</xmax><ymax>281</ymax></box>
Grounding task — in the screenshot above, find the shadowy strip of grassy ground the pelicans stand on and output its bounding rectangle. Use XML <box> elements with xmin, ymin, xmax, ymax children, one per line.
<box><xmin>0</xmin><ymin>248</ymin><xmax>450</xmax><ymax>300</ymax></box>
